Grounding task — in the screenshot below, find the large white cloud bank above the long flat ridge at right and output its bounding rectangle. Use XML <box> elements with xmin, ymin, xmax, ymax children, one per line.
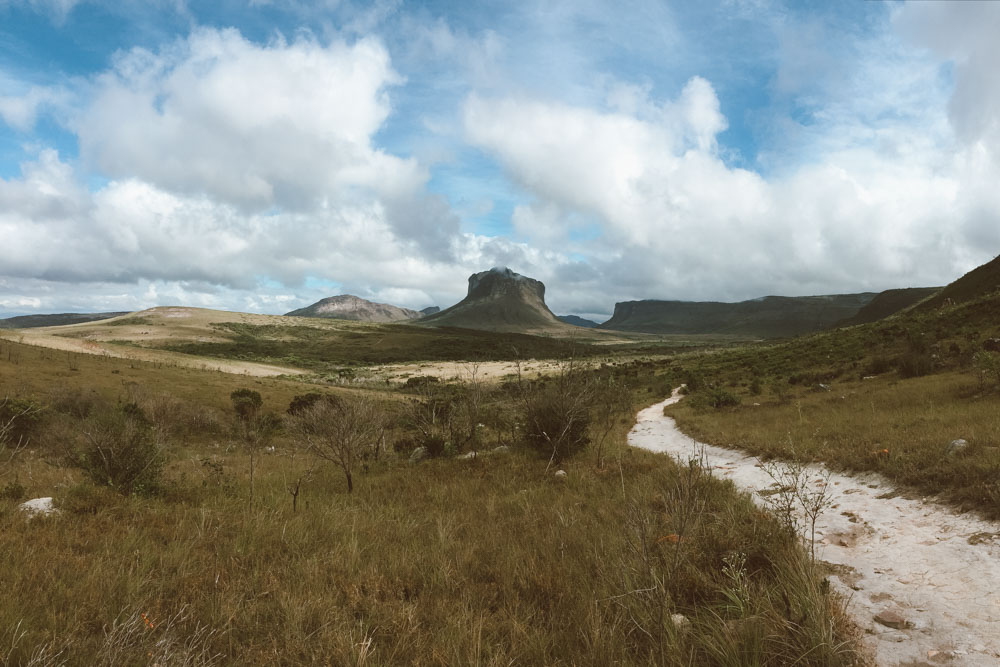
<box><xmin>464</xmin><ymin>70</ymin><xmax>997</xmax><ymax>299</ymax></box>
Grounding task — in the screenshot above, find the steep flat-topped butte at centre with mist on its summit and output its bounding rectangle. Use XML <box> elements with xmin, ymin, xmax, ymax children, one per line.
<box><xmin>420</xmin><ymin>267</ymin><xmax>569</xmax><ymax>332</ymax></box>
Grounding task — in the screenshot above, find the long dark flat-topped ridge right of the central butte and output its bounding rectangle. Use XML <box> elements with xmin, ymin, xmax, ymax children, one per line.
<box><xmin>600</xmin><ymin>292</ymin><xmax>876</xmax><ymax>338</ymax></box>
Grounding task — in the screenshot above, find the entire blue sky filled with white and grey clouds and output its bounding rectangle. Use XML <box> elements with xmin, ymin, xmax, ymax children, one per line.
<box><xmin>0</xmin><ymin>0</ymin><xmax>1000</xmax><ymax>320</ymax></box>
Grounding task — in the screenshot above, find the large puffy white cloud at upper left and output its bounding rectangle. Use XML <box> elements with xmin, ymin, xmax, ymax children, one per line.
<box><xmin>75</xmin><ymin>29</ymin><xmax>458</xmax><ymax>256</ymax></box>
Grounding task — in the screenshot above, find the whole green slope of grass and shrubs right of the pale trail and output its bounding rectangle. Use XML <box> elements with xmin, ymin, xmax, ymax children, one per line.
<box><xmin>671</xmin><ymin>292</ymin><xmax>1000</xmax><ymax>518</ymax></box>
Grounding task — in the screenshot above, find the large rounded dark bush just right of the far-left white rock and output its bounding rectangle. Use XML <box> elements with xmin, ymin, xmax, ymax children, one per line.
<box><xmin>71</xmin><ymin>404</ymin><xmax>163</xmax><ymax>495</ymax></box>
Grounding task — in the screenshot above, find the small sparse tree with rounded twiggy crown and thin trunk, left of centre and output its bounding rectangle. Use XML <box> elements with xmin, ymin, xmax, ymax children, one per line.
<box><xmin>292</xmin><ymin>396</ymin><xmax>385</xmax><ymax>493</ymax></box>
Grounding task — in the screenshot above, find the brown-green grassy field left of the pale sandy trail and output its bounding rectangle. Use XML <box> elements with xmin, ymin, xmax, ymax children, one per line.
<box><xmin>0</xmin><ymin>342</ymin><xmax>860</xmax><ymax>665</ymax></box>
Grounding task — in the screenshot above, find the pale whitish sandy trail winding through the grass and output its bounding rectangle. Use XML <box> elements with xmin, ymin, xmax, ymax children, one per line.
<box><xmin>628</xmin><ymin>392</ymin><xmax>1000</xmax><ymax>665</ymax></box>
